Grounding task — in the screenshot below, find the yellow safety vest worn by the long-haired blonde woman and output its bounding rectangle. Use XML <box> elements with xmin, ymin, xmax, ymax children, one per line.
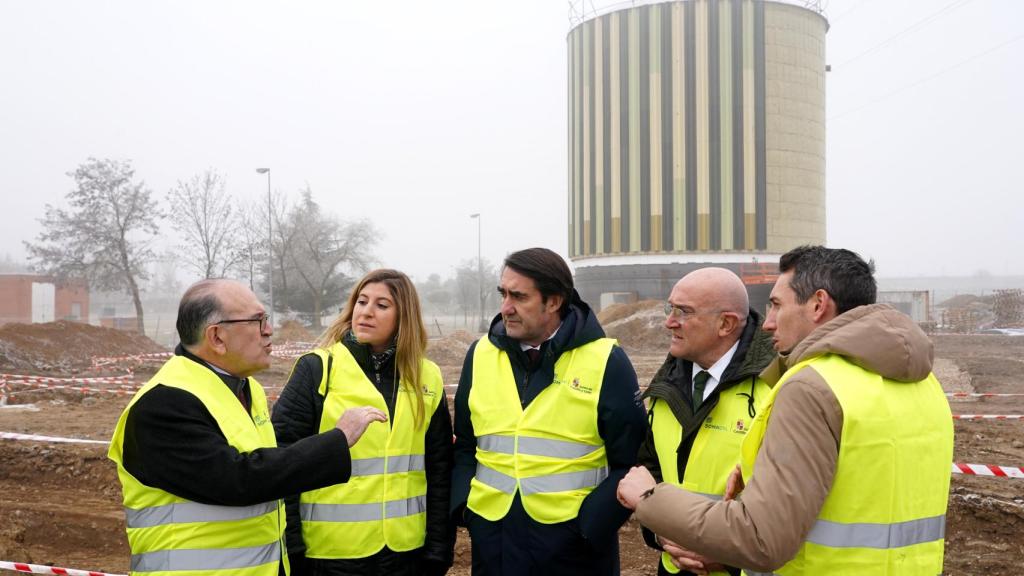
<box><xmin>299</xmin><ymin>342</ymin><xmax>444</xmax><ymax>559</ymax></box>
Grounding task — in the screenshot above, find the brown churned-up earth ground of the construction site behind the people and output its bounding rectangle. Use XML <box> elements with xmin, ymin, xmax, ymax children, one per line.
<box><xmin>0</xmin><ymin>315</ymin><xmax>1024</xmax><ymax>576</ymax></box>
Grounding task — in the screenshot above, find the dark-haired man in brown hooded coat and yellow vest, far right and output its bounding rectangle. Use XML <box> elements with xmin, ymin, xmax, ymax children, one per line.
<box><xmin>618</xmin><ymin>246</ymin><xmax>953</xmax><ymax>576</ymax></box>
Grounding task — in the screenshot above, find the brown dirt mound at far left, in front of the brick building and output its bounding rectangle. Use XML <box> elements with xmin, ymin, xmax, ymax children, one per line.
<box><xmin>0</xmin><ymin>320</ymin><xmax>167</xmax><ymax>373</ymax></box>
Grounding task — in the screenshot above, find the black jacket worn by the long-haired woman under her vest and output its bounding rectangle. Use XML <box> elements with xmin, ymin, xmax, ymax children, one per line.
<box><xmin>271</xmin><ymin>341</ymin><xmax>455</xmax><ymax>576</ymax></box>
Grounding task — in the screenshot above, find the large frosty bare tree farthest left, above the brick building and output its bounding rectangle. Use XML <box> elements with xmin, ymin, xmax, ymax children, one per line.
<box><xmin>25</xmin><ymin>158</ymin><xmax>161</xmax><ymax>334</ymax></box>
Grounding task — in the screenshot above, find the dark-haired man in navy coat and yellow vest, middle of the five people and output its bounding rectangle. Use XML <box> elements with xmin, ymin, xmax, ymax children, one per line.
<box><xmin>452</xmin><ymin>248</ymin><xmax>646</xmax><ymax>576</ymax></box>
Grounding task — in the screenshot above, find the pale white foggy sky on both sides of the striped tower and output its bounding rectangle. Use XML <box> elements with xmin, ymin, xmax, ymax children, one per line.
<box><xmin>0</xmin><ymin>0</ymin><xmax>1024</xmax><ymax>279</ymax></box>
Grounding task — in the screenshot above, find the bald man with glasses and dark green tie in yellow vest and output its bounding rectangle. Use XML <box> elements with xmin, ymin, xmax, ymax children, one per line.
<box><xmin>626</xmin><ymin>268</ymin><xmax>775</xmax><ymax>575</ymax></box>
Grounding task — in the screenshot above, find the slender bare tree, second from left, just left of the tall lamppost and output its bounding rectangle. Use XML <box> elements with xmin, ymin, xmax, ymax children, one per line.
<box><xmin>167</xmin><ymin>168</ymin><xmax>243</xmax><ymax>278</ymax></box>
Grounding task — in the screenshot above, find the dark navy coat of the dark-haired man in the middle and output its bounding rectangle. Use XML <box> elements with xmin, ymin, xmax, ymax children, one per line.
<box><xmin>452</xmin><ymin>294</ymin><xmax>647</xmax><ymax>576</ymax></box>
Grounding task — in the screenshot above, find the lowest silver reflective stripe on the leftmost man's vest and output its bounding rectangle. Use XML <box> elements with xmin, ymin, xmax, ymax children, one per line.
<box><xmin>131</xmin><ymin>542</ymin><xmax>281</xmax><ymax>574</ymax></box>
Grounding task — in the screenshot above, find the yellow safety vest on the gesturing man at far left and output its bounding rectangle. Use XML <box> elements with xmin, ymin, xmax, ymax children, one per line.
<box><xmin>106</xmin><ymin>356</ymin><xmax>289</xmax><ymax>576</ymax></box>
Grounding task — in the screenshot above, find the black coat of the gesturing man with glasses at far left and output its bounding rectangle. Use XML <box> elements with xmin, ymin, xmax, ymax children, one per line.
<box><xmin>122</xmin><ymin>345</ymin><xmax>351</xmax><ymax>573</ymax></box>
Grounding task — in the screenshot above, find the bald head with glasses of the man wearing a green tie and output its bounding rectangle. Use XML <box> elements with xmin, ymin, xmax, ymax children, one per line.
<box><xmin>665</xmin><ymin>268</ymin><xmax>750</xmax><ymax>369</ymax></box>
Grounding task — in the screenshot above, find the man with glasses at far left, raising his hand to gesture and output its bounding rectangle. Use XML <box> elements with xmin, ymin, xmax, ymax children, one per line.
<box><xmin>108</xmin><ymin>280</ymin><xmax>387</xmax><ymax>576</ymax></box>
